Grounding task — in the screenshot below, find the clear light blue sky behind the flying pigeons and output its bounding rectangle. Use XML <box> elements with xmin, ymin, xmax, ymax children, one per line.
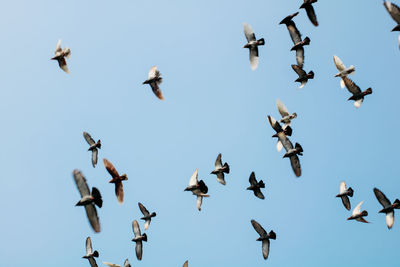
<box><xmin>0</xmin><ymin>0</ymin><xmax>400</xmax><ymax>267</ymax></box>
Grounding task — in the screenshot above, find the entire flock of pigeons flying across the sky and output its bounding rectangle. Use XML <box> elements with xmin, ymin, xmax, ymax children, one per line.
<box><xmin>47</xmin><ymin>0</ymin><xmax>400</xmax><ymax>267</ymax></box>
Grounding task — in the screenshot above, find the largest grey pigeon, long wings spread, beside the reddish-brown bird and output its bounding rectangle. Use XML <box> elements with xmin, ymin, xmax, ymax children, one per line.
<box><xmin>73</xmin><ymin>169</ymin><xmax>103</xmax><ymax>233</ymax></box>
